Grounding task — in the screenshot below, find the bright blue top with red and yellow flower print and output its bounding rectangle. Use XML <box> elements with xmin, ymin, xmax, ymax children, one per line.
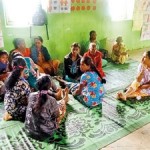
<box><xmin>77</xmin><ymin>71</ymin><xmax>105</xmax><ymax>107</ymax></box>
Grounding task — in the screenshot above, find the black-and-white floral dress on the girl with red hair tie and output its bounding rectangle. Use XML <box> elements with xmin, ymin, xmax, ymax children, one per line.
<box><xmin>4</xmin><ymin>78</ymin><xmax>31</xmax><ymax>120</ymax></box>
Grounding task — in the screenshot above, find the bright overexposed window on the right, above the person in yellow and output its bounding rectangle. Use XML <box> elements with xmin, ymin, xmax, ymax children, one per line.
<box><xmin>108</xmin><ymin>0</ymin><xmax>134</xmax><ymax>21</ymax></box>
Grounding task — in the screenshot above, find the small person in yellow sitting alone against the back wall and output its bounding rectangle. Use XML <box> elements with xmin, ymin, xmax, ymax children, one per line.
<box><xmin>112</xmin><ymin>36</ymin><xmax>128</xmax><ymax>64</ymax></box>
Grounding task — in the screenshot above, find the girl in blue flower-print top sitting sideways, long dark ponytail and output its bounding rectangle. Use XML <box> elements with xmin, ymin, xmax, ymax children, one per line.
<box><xmin>56</xmin><ymin>57</ymin><xmax>106</xmax><ymax>107</ymax></box>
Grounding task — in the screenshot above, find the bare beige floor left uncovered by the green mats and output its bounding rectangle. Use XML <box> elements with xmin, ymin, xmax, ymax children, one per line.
<box><xmin>102</xmin><ymin>49</ymin><xmax>150</xmax><ymax>150</ymax></box>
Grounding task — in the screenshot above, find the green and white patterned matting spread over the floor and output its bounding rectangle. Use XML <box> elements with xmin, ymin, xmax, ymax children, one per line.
<box><xmin>0</xmin><ymin>61</ymin><xmax>150</xmax><ymax>150</ymax></box>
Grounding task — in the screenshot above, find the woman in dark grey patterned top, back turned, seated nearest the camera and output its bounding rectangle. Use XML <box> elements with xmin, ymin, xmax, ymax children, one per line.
<box><xmin>25</xmin><ymin>75</ymin><xmax>68</xmax><ymax>139</ymax></box>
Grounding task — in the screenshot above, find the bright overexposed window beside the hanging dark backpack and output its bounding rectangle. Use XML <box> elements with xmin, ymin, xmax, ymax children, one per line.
<box><xmin>3</xmin><ymin>0</ymin><xmax>46</xmax><ymax>27</ymax></box>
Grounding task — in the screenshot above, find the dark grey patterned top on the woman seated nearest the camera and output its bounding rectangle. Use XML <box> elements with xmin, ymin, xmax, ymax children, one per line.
<box><xmin>25</xmin><ymin>92</ymin><xmax>59</xmax><ymax>138</ymax></box>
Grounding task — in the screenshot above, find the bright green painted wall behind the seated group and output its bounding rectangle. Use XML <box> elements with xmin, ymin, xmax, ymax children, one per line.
<box><xmin>0</xmin><ymin>0</ymin><xmax>150</xmax><ymax>61</ymax></box>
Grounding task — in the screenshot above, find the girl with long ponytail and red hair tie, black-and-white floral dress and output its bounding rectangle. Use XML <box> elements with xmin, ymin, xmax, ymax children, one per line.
<box><xmin>4</xmin><ymin>57</ymin><xmax>30</xmax><ymax>120</ymax></box>
